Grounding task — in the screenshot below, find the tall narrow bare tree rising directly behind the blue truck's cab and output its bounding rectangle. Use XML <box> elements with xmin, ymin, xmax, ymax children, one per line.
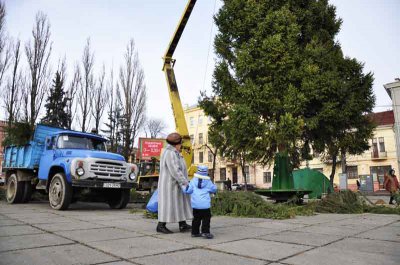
<box><xmin>78</xmin><ymin>38</ymin><xmax>95</xmax><ymax>132</ymax></box>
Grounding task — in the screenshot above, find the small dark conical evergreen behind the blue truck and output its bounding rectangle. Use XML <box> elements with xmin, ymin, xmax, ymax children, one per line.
<box><xmin>42</xmin><ymin>71</ymin><xmax>69</xmax><ymax>128</ymax></box>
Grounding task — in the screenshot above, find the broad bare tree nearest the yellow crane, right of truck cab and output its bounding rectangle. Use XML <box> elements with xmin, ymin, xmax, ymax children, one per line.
<box><xmin>118</xmin><ymin>39</ymin><xmax>146</xmax><ymax>159</ymax></box>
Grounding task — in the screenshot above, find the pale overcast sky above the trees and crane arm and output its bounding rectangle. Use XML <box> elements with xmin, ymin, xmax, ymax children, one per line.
<box><xmin>1</xmin><ymin>0</ymin><xmax>400</xmax><ymax>135</ymax></box>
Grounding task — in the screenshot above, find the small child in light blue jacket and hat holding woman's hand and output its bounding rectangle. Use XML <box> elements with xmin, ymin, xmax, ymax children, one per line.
<box><xmin>186</xmin><ymin>166</ymin><xmax>217</xmax><ymax>239</ymax></box>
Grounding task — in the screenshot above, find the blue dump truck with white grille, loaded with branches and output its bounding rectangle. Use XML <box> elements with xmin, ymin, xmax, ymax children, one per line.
<box><xmin>2</xmin><ymin>124</ymin><xmax>137</xmax><ymax>210</ymax></box>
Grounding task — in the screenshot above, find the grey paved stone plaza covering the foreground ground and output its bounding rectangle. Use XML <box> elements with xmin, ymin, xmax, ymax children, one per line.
<box><xmin>0</xmin><ymin>202</ymin><xmax>400</xmax><ymax>265</ymax></box>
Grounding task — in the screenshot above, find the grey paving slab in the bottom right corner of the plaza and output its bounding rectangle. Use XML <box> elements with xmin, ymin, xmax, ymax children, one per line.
<box><xmin>282</xmin><ymin>246</ymin><xmax>400</xmax><ymax>265</ymax></box>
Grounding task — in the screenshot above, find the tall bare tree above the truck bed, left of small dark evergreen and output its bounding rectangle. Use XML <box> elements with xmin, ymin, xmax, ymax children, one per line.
<box><xmin>25</xmin><ymin>12</ymin><xmax>52</xmax><ymax>128</ymax></box>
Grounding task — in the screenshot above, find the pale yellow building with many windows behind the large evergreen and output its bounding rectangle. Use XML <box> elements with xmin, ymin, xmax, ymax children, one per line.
<box><xmin>184</xmin><ymin>106</ymin><xmax>398</xmax><ymax>190</ymax></box>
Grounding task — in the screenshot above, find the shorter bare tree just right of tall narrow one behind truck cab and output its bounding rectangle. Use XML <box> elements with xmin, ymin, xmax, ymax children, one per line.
<box><xmin>92</xmin><ymin>64</ymin><xmax>106</xmax><ymax>132</ymax></box>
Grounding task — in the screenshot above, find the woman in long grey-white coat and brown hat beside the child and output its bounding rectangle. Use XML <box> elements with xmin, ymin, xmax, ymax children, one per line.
<box><xmin>157</xmin><ymin>133</ymin><xmax>193</xmax><ymax>234</ymax></box>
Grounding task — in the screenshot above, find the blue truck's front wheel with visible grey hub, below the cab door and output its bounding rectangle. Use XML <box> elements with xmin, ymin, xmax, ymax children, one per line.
<box><xmin>49</xmin><ymin>173</ymin><xmax>72</xmax><ymax>210</ymax></box>
